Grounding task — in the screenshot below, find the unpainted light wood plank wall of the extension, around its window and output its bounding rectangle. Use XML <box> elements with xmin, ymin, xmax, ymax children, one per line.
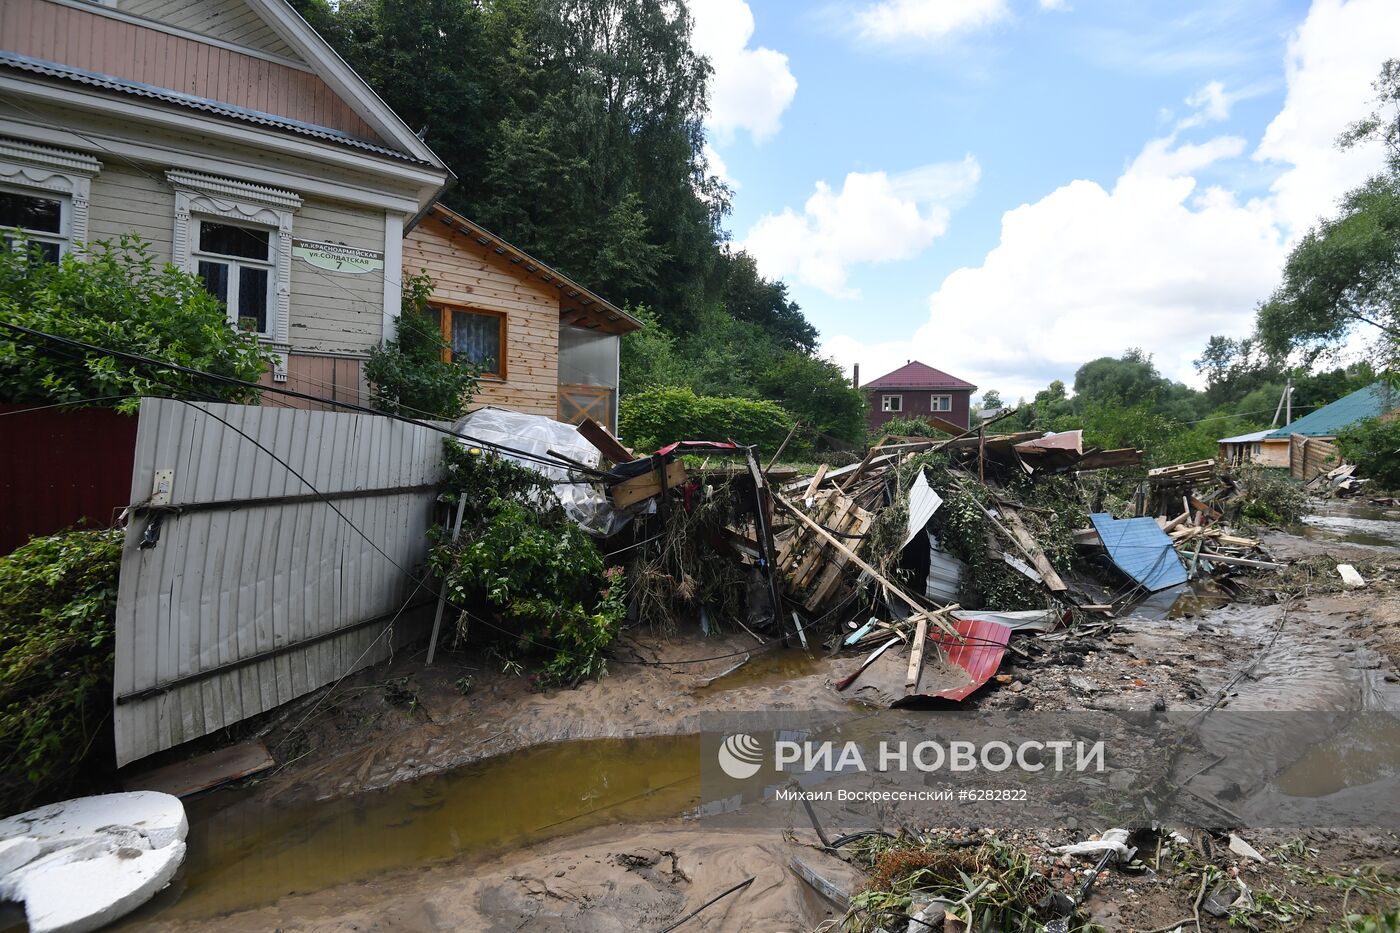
<box><xmin>403</xmin><ymin>214</ymin><xmax>559</xmax><ymax>417</ymax></box>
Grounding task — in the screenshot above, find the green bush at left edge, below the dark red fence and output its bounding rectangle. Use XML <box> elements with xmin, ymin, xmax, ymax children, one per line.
<box><xmin>0</xmin><ymin>531</ymin><xmax>122</xmax><ymax>813</ymax></box>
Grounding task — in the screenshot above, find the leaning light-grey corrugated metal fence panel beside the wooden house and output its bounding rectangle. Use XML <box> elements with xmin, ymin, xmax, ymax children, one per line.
<box><xmin>115</xmin><ymin>399</ymin><xmax>442</xmax><ymax>765</ymax></box>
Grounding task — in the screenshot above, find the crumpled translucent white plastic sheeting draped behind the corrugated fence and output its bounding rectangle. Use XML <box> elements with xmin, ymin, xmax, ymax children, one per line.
<box><xmin>452</xmin><ymin>408</ymin><xmax>632</xmax><ymax>538</ymax></box>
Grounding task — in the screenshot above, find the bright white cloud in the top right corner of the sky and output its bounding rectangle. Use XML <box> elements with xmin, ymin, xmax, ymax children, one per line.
<box><xmin>1254</xmin><ymin>0</ymin><xmax>1400</xmax><ymax>237</ymax></box>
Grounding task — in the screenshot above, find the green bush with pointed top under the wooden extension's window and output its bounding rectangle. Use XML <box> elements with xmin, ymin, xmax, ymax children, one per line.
<box><xmin>364</xmin><ymin>273</ymin><xmax>480</xmax><ymax>422</ymax></box>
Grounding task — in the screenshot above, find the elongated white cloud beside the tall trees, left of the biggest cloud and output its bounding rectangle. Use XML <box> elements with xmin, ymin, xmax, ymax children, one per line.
<box><xmin>742</xmin><ymin>156</ymin><xmax>981</xmax><ymax>297</ymax></box>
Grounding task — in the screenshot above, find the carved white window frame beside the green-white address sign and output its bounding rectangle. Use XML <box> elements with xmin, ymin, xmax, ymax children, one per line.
<box><xmin>165</xmin><ymin>170</ymin><xmax>301</xmax><ymax>364</ymax></box>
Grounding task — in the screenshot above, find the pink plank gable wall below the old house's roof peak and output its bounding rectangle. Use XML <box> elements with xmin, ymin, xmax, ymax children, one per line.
<box><xmin>0</xmin><ymin>0</ymin><xmax>384</xmax><ymax>143</ymax></box>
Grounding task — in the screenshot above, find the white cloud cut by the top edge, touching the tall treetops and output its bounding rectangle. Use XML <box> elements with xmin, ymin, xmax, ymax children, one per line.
<box><xmin>690</xmin><ymin>0</ymin><xmax>797</xmax><ymax>143</ymax></box>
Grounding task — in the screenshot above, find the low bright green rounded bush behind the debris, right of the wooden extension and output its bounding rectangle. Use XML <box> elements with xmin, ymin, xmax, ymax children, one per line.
<box><xmin>620</xmin><ymin>387</ymin><xmax>797</xmax><ymax>451</ymax></box>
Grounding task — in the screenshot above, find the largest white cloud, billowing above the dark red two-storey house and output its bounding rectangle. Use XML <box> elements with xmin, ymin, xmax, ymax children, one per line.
<box><xmin>825</xmin><ymin>137</ymin><xmax>1282</xmax><ymax>398</ymax></box>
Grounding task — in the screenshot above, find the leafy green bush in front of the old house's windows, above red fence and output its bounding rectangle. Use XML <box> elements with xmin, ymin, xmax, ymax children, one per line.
<box><xmin>0</xmin><ymin>234</ymin><xmax>272</xmax><ymax>410</ymax></box>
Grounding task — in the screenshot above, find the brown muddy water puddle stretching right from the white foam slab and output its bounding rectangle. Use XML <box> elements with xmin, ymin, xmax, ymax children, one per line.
<box><xmin>123</xmin><ymin>735</ymin><xmax>700</xmax><ymax>929</ymax></box>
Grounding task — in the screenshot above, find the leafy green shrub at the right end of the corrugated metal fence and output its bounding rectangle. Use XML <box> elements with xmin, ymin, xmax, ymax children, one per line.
<box><xmin>428</xmin><ymin>440</ymin><xmax>626</xmax><ymax>685</ymax></box>
